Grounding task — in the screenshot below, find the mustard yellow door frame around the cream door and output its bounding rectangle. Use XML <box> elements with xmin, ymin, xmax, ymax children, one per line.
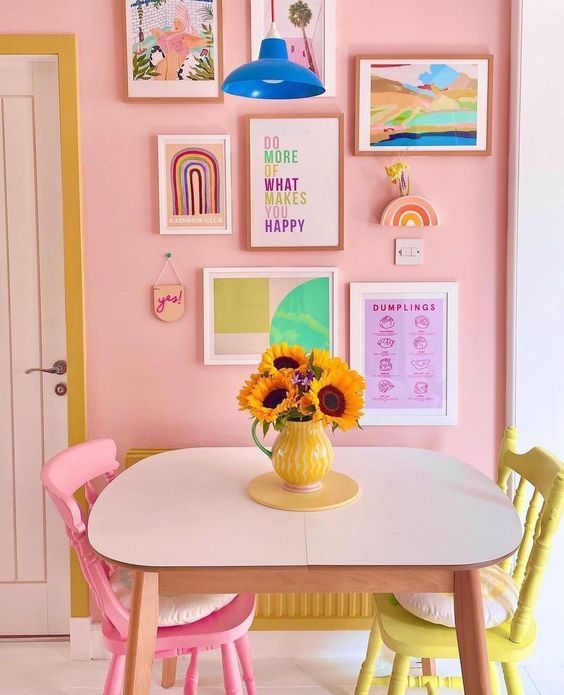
<box><xmin>0</xmin><ymin>34</ymin><xmax>90</xmax><ymax>618</ymax></box>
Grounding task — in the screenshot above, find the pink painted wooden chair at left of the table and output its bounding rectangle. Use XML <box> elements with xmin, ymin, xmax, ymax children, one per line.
<box><xmin>41</xmin><ymin>439</ymin><xmax>256</xmax><ymax>695</ymax></box>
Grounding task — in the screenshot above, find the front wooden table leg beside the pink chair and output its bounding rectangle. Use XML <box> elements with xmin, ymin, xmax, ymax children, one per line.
<box><xmin>123</xmin><ymin>572</ymin><xmax>159</xmax><ymax>695</ymax></box>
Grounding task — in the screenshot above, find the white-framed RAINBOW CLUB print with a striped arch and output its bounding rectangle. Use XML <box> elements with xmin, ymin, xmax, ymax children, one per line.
<box><xmin>158</xmin><ymin>135</ymin><xmax>231</xmax><ymax>234</ymax></box>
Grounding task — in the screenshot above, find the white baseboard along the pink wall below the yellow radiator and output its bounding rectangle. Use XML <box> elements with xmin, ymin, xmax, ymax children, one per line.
<box><xmin>83</xmin><ymin>623</ymin><xmax>378</xmax><ymax>661</ymax></box>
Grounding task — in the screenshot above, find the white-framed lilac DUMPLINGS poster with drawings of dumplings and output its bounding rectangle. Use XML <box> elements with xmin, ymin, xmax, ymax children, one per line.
<box><xmin>350</xmin><ymin>282</ymin><xmax>458</xmax><ymax>425</ymax></box>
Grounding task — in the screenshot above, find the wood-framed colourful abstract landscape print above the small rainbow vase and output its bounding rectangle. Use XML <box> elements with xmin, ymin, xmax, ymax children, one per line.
<box><xmin>355</xmin><ymin>55</ymin><xmax>493</xmax><ymax>155</ymax></box>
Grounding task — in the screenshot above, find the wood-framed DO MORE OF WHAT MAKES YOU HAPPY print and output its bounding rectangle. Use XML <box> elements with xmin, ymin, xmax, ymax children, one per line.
<box><xmin>247</xmin><ymin>114</ymin><xmax>343</xmax><ymax>250</ymax></box>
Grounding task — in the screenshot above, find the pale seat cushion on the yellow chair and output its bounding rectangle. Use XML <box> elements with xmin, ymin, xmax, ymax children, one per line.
<box><xmin>395</xmin><ymin>565</ymin><xmax>519</xmax><ymax>628</ymax></box>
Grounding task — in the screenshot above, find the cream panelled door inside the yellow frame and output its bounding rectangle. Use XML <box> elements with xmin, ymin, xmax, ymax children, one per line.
<box><xmin>0</xmin><ymin>56</ymin><xmax>69</xmax><ymax>636</ymax></box>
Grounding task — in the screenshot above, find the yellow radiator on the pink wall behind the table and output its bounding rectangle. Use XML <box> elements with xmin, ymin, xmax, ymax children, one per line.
<box><xmin>125</xmin><ymin>449</ymin><xmax>374</xmax><ymax>630</ymax></box>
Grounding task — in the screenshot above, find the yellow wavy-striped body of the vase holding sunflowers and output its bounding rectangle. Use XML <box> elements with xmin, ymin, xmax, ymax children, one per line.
<box><xmin>272</xmin><ymin>422</ymin><xmax>333</xmax><ymax>492</ymax></box>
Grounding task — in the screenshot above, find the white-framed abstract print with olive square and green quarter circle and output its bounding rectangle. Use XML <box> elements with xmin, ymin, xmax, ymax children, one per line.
<box><xmin>204</xmin><ymin>268</ymin><xmax>337</xmax><ymax>364</ymax></box>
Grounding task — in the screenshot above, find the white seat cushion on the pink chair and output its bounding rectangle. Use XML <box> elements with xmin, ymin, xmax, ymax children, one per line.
<box><xmin>110</xmin><ymin>567</ymin><xmax>237</xmax><ymax>627</ymax></box>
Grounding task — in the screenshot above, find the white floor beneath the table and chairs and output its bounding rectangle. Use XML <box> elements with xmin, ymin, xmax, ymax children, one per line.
<box><xmin>0</xmin><ymin>642</ymin><xmax>564</xmax><ymax>695</ymax></box>
